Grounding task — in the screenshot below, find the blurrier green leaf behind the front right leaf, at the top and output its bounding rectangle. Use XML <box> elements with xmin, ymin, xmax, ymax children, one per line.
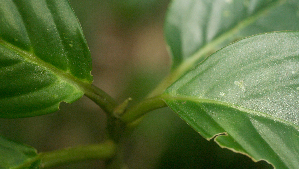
<box><xmin>165</xmin><ymin>0</ymin><xmax>299</xmax><ymax>70</ymax></box>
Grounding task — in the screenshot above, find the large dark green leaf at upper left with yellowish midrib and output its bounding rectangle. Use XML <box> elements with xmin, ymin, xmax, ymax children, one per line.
<box><xmin>0</xmin><ymin>0</ymin><xmax>92</xmax><ymax>118</ymax></box>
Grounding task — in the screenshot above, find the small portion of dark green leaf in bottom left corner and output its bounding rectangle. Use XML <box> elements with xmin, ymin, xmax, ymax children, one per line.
<box><xmin>0</xmin><ymin>136</ymin><xmax>40</xmax><ymax>169</ymax></box>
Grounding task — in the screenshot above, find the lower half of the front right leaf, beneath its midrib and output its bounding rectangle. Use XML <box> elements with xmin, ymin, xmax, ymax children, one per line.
<box><xmin>166</xmin><ymin>99</ymin><xmax>299</xmax><ymax>168</ymax></box>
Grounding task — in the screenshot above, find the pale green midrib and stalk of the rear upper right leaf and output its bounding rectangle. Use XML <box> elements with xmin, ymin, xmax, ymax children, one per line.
<box><xmin>148</xmin><ymin>0</ymin><xmax>286</xmax><ymax>97</ymax></box>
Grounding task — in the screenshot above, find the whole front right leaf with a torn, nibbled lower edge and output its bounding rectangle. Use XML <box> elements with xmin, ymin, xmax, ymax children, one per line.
<box><xmin>163</xmin><ymin>32</ymin><xmax>299</xmax><ymax>169</ymax></box>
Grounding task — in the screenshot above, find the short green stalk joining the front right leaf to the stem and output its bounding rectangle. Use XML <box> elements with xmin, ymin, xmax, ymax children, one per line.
<box><xmin>120</xmin><ymin>96</ymin><xmax>167</xmax><ymax>124</ymax></box>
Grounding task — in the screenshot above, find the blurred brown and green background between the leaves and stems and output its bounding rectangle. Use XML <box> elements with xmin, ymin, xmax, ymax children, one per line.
<box><xmin>0</xmin><ymin>0</ymin><xmax>272</xmax><ymax>169</ymax></box>
